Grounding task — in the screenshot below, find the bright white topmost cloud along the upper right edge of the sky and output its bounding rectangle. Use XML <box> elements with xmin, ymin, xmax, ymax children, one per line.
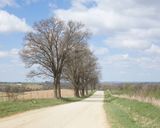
<box><xmin>55</xmin><ymin>0</ymin><xmax>160</xmax><ymax>33</ymax></box>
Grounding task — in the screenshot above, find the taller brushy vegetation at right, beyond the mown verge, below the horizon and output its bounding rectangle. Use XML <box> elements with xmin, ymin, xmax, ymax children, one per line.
<box><xmin>106</xmin><ymin>83</ymin><xmax>160</xmax><ymax>99</ymax></box>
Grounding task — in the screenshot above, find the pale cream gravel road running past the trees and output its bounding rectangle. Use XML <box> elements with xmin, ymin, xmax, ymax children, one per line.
<box><xmin>0</xmin><ymin>91</ymin><xmax>109</xmax><ymax>128</ymax></box>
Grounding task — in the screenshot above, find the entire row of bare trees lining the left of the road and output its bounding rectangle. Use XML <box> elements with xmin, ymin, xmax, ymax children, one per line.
<box><xmin>20</xmin><ymin>18</ymin><xmax>99</xmax><ymax>98</ymax></box>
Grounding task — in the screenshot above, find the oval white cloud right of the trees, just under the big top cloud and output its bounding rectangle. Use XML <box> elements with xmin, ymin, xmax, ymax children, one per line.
<box><xmin>105</xmin><ymin>30</ymin><xmax>152</xmax><ymax>50</ymax></box>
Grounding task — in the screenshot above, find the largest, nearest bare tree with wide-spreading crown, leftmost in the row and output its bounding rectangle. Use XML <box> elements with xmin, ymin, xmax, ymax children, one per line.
<box><xmin>20</xmin><ymin>18</ymin><xmax>89</xmax><ymax>98</ymax></box>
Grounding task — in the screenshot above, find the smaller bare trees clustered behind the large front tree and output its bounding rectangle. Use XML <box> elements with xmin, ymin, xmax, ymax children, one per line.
<box><xmin>63</xmin><ymin>43</ymin><xmax>98</xmax><ymax>97</ymax></box>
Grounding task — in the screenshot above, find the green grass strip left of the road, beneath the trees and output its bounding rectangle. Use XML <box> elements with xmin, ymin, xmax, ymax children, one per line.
<box><xmin>0</xmin><ymin>93</ymin><xmax>93</xmax><ymax>118</ymax></box>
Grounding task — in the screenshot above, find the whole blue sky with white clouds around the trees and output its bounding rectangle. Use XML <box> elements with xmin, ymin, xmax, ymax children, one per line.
<box><xmin>0</xmin><ymin>0</ymin><xmax>160</xmax><ymax>82</ymax></box>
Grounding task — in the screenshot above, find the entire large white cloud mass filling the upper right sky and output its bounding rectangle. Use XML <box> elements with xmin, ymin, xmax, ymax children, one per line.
<box><xmin>54</xmin><ymin>0</ymin><xmax>160</xmax><ymax>51</ymax></box>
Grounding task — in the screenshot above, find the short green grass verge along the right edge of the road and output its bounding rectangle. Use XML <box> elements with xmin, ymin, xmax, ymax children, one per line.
<box><xmin>104</xmin><ymin>91</ymin><xmax>160</xmax><ymax>128</ymax></box>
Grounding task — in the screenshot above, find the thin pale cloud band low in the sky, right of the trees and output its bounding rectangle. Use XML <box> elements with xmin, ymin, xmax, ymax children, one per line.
<box><xmin>103</xmin><ymin>54</ymin><xmax>160</xmax><ymax>71</ymax></box>
